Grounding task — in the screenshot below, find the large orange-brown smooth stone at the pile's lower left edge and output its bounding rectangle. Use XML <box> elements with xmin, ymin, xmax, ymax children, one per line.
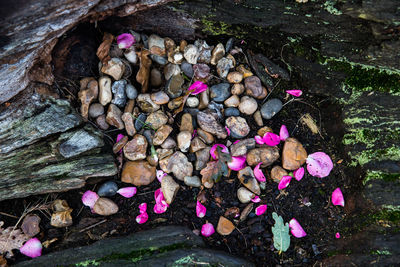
<box><xmin>121</xmin><ymin>160</ymin><xmax>156</xmax><ymax>186</ymax></box>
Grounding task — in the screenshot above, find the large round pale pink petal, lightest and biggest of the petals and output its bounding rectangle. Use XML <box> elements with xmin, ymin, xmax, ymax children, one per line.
<box><xmin>306</xmin><ymin>152</ymin><xmax>333</xmax><ymax>178</ymax></box>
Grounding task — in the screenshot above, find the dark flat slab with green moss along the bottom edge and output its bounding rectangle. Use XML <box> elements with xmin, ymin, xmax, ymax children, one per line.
<box><xmin>16</xmin><ymin>226</ymin><xmax>253</xmax><ymax>266</ymax></box>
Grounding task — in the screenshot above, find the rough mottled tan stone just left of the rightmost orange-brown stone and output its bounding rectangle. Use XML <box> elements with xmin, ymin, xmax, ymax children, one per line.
<box><xmin>246</xmin><ymin>146</ymin><xmax>279</xmax><ymax>168</ymax></box>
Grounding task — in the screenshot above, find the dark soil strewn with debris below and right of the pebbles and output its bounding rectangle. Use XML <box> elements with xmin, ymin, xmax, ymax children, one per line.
<box><xmin>0</xmin><ymin>21</ymin><xmax>349</xmax><ymax>266</ymax></box>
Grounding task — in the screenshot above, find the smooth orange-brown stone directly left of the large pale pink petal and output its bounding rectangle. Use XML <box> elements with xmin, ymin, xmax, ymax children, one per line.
<box><xmin>282</xmin><ymin>137</ymin><xmax>307</xmax><ymax>171</ymax></box>
